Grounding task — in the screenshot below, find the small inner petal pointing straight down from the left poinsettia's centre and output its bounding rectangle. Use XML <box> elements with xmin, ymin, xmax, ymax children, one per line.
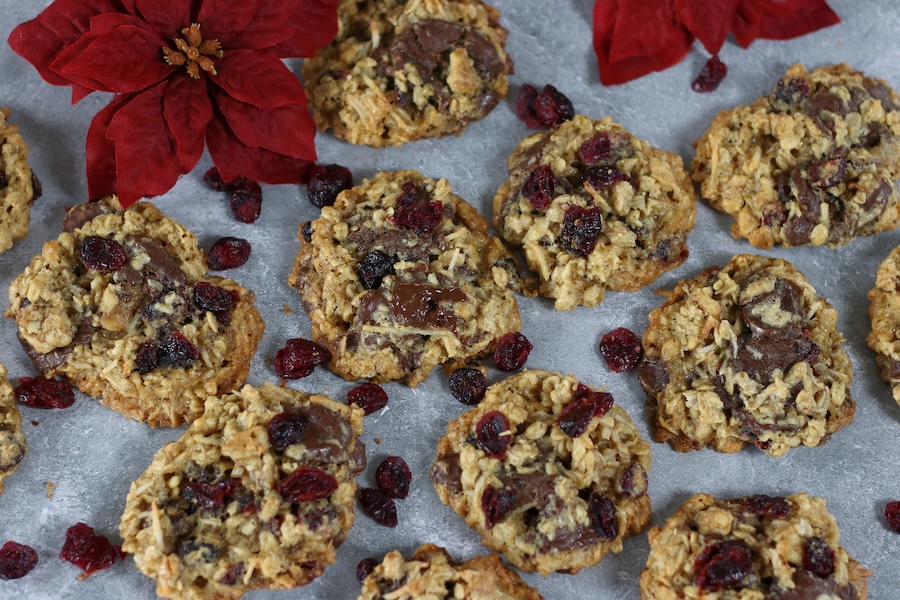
<box><xmin>163</xmin><ymin>75</ymin><xmax>212</xmax><ymax>173</ymax></box>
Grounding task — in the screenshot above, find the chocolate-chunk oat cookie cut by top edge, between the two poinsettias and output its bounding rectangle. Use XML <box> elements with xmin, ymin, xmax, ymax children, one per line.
<box><xmin>303</xmin><ymin>0</ymin><xmax>512</xmax><ymax>147</ymax></box>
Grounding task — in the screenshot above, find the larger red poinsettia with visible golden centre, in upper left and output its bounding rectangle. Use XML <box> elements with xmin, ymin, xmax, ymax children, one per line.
<box><xmin>9</xmin><ymin>0</ymin><xmax>338</xmax><ymax>206</ymax></box>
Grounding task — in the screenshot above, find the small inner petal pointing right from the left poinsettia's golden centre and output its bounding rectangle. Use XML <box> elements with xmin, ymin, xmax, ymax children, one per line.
<box><xmin>212</xmin><ymin>50</ymin><xmax>306</xmax><ymax>108</ymax></box>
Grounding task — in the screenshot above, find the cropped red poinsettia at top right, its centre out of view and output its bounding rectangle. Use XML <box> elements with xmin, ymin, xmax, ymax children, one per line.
<box><xmin>594</xmin><ymin>0</ymin><xmax>840</xmax><ymax>85</ymax></box>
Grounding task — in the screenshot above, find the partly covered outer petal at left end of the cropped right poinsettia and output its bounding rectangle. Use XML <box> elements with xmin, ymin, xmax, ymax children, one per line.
<box><xmin>594</xmin><ymin>0</ymin><xmax>693</xmax><ymax>85</ymax></box>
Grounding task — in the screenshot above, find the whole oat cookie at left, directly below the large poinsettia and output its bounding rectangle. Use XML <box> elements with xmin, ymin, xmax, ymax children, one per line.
<box><xmin>6</xmin><ymin>198</ymin><xmax>263</xmax><ymax>426</ymax></box>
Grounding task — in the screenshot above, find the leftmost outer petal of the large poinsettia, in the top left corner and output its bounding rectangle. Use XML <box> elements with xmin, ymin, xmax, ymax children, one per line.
<box><xmin>8</xmin><ymin>0</ymin><xmax>122</xmax><ymax>85</ymax></box>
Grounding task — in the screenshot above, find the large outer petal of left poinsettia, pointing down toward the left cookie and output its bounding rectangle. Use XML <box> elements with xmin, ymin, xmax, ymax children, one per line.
<box><xmin>106</xmin><ymin>81</ymin><xmax>186</xmax><ymax>204</ymax></box>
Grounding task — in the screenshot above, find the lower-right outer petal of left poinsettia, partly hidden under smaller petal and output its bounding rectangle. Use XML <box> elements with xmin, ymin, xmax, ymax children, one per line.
<box><xmin>206</xmin><ymin>114</ymin><xmax>315</xmax><ymax>183</ymax></box>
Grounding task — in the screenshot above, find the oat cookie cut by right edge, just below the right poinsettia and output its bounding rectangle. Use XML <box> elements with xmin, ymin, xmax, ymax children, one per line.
<box><xmin>693</xmin><ymin>64</ymin><xmax>900</xmax><ymax>248</ymax></box>
